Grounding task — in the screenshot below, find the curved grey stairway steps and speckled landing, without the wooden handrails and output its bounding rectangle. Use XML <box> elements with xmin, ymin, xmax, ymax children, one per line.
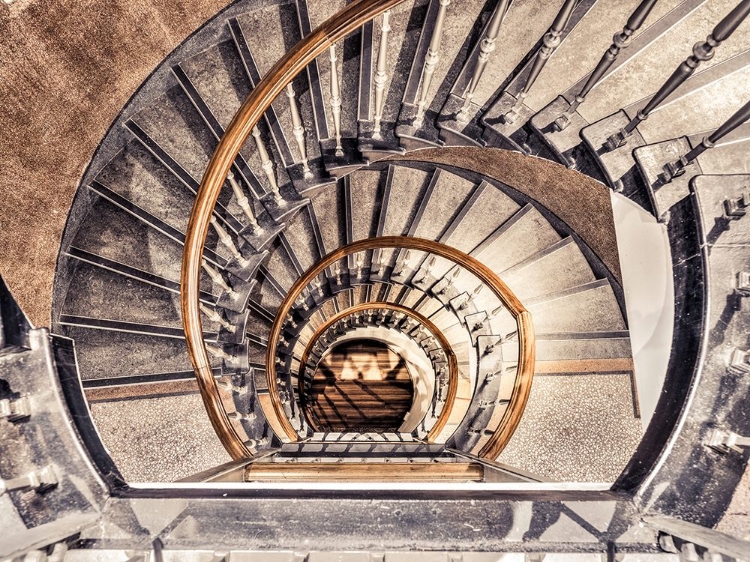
<box><xmin>54</xmin><ymin>0</ymin><xmax>750</xmax><ymax>481</ymax></box>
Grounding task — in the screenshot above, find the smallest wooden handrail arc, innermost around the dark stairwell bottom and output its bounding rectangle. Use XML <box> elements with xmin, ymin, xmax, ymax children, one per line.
<box><xmin>299</xmin><ymin>302</ymin><xmax>458</xmax><ymax>443</ymax></box>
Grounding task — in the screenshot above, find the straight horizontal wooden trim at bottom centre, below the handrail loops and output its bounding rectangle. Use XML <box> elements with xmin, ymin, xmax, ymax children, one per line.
<box><xmin>245</xmin><ymin>462</ymin><xmax>484</xmax><ymax>482</ymax></box>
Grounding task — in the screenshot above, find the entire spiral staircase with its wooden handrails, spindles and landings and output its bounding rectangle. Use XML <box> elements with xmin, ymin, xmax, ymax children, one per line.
<box><xmin>0</xmin><ymin>0</ymin><xmax>750</xmax><ymax>560</ymax></box>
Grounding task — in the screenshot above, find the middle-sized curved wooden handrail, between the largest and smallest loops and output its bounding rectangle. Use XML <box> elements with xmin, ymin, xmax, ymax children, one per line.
<box><xmin>262</xmin><ymin>236</ymin><xmax>536</xmax><ymax>460</ymax></box>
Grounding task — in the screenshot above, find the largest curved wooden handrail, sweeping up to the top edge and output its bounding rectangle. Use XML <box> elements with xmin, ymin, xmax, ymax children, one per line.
<box><xmin>180</xmin><ymin>0</ymin><xmax>404</xmax><ymax>459</ymax></box>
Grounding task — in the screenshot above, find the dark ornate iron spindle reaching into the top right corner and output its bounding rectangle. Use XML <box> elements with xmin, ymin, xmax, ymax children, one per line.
<box><xmin>605</xmin><ymin>0</ymin><xmax>750</xmax><ymax>150</ymax></box>
